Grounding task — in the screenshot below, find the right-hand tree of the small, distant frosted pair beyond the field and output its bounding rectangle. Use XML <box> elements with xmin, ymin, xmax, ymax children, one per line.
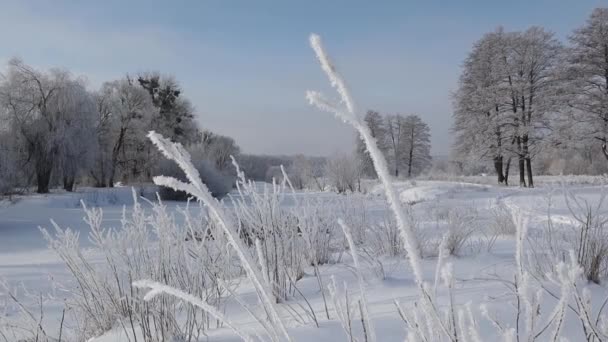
<box><xmin>401</xmin><ymin>115</ymin><xmax>431</xmax><ymax>177</ymax></box>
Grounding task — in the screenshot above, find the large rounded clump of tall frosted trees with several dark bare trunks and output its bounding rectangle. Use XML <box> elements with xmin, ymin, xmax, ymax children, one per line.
<box><xmin>454</xmin><ymin>27</ymin><xmax>562</xmax><ymax>187</ymax></box>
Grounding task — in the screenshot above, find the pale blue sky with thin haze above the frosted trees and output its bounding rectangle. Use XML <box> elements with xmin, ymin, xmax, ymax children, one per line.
<box><xmin>0</xmin><ymin>0</ymin><xmax>608</xmax><ymax>155</ymax></box>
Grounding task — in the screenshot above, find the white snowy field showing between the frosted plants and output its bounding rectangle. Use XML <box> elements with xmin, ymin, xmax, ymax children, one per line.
<box><xmin>0</xmin><ymin>181</ymin><xmax>607</xmax><ymax>342</ymax></box>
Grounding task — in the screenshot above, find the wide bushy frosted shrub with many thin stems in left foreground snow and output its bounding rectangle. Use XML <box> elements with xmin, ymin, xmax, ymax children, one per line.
<box><xmin>43</xmin><ymin>192</ymin><xmax>241</xmax><ymax>341</ymax></box>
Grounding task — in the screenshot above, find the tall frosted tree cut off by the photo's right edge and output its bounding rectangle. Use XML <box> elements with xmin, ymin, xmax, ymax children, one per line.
<box><xmin>564</xmin><ymin>8</ymin><xmax>608</xmax><ymax>159</ymax></box>
